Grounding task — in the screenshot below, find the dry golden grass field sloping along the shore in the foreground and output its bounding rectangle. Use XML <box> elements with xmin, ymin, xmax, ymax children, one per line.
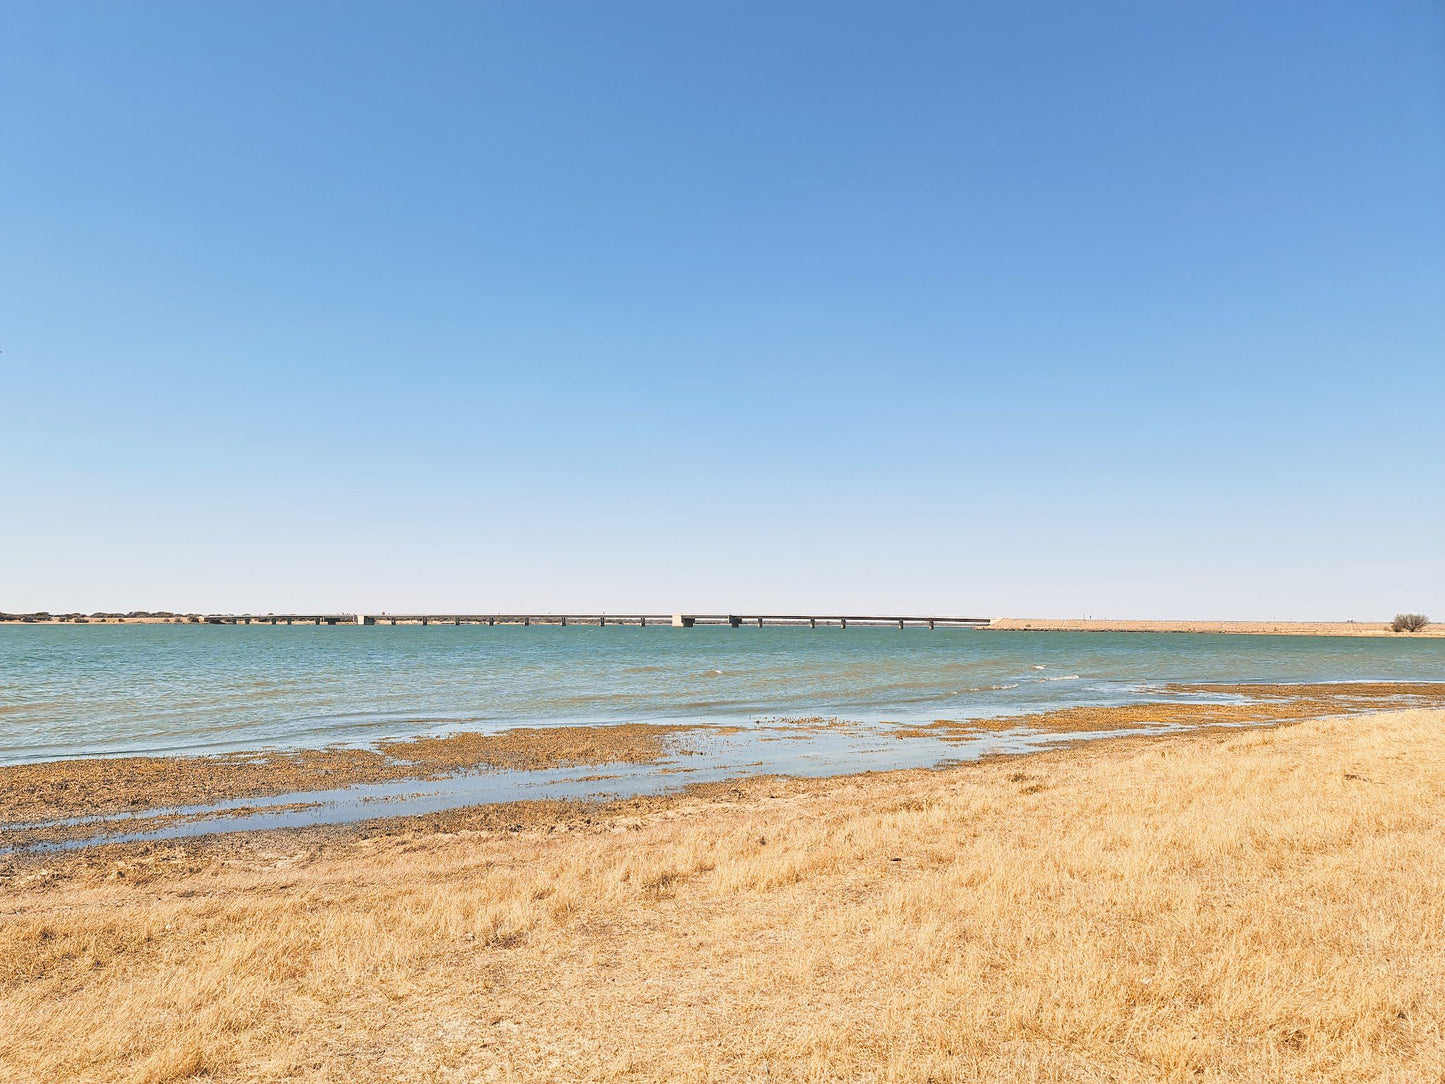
<box><xmin>0</xmin><ymin>710</ymin><xmax>1445</xmax><ymax>1084</ymax></box>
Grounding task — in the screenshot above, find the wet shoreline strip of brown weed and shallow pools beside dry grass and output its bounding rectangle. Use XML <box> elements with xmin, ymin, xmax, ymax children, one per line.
<box><xmin>11</xmin><ymin>682</ymin><xmax>1445</xmax><ymax>854</ymax></box>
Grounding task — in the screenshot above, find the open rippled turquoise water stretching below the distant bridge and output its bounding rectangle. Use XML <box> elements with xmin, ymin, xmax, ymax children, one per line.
<box><xmin>0</xmin><ymin>624</ymin><xmax>1445</xmax><ymax>763</ymax></box>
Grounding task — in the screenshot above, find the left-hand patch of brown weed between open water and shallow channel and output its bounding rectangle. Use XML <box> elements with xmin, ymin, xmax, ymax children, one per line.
<box><xmin>0</xmin><ymin>723</ymin><xmax>709</xmax><ymax>825</ymax></box>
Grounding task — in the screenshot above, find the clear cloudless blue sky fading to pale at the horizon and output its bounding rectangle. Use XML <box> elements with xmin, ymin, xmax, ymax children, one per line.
<box><xmin>0</xmin><ymin>0</ymin><xmax>1445</xmax><ymax>619</ymax></box>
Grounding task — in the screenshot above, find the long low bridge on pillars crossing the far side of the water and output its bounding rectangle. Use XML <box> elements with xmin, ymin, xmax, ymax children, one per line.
<box><xmin>192</xmin><ymin>613</ymin><xmax>990</xmax><ymax>629</ymax></box>
